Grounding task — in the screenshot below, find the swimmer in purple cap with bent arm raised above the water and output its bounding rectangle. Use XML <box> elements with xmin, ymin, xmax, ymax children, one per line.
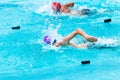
<box><xmin>44</xmin><ymin>29</ymin><xmax>98</xmax><ymax>48</ymax></box>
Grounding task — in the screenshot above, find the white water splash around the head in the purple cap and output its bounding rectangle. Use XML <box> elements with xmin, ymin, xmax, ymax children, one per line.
<box><xmin>38</xmin><ymin>24</ymin><xmax>62</xmax><ymax>52</ymax></box>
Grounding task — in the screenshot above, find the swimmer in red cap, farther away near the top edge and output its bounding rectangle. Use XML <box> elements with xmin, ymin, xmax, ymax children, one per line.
<box><xmin>52</xmin><ymin>2</ymin><xmax>91</xmax><ymax>16</ymax></box>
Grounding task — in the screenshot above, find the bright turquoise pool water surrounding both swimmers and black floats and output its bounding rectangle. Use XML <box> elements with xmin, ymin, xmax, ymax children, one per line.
<box><xmin>0</xmin><ymin>0</ymin><xmax>120</xmax><ymax>80</ymax></box>
